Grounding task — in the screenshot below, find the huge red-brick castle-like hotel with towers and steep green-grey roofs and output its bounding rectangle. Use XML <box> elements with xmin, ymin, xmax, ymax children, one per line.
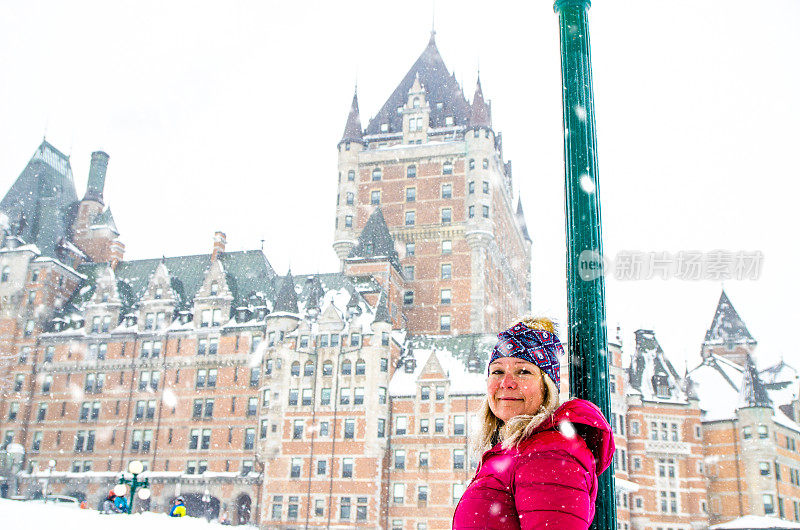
<box><xmin>0</xmin><ymin>35</ymin><xmax>800</xmax><ymax>530</ymax></box>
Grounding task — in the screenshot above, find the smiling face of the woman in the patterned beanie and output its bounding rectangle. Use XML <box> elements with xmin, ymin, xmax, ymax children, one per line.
<box><xmin>486</xmin><ymin>357</ymin><xmax>544</xmax><ymax>422</ymax></box>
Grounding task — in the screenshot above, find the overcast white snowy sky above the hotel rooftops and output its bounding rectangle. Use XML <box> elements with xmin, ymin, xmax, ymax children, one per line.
<box><xmin>0</xmin><ymin>0</ymin><xmax>800</xmax><ymax>371</ymax></box>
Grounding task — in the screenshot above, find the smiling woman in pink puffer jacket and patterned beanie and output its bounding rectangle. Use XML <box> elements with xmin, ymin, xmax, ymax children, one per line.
<box><xmin>453</xmin><ymin>318</ymin><xmax>614</xmax><ymax>530</ymax></box>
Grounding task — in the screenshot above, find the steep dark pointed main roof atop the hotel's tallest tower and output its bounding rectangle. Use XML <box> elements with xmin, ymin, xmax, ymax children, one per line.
<box><xmin>366</xmin><ymin>32</ymin><xmax>470</xmax><ymax>134</ymax></box>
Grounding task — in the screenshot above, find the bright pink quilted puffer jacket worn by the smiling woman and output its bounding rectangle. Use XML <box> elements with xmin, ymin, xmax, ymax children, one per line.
<box><xmin>453</xmin><ymin>399</ymin><xmax>614</xmax><ymax>530</ymax></box>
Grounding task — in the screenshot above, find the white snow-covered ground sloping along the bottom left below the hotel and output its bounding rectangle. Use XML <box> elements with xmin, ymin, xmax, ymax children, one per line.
<box><xmin>0</xmin><ymin>499</ymin><xmax>232</xmax><ymax>530</ymax></box>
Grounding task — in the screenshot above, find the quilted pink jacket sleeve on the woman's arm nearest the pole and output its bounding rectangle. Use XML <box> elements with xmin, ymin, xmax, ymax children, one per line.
<box><xmin>514</xmin><ymin>451</ymin><xmax>595</xmax><ymax>530</ymax></box>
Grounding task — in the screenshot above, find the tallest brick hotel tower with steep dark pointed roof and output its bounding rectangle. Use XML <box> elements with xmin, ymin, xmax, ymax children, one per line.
<box><xmin>333</xmin><ymin>34</ymin><xmax>531</xmax><ymax>334</ymax></box>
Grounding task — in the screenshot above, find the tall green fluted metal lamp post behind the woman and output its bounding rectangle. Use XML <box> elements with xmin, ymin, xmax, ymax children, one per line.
<box><xmin>554</xmin><ymin>0</ymin><xmax>617</xmax><ymax>530</ymax></box>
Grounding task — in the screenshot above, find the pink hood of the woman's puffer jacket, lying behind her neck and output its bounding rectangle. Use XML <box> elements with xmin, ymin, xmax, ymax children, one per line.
<box><xmin>534</xmin><ymin>399</ymin><xmax>615</xmax><ymax>475</ymax></box>
